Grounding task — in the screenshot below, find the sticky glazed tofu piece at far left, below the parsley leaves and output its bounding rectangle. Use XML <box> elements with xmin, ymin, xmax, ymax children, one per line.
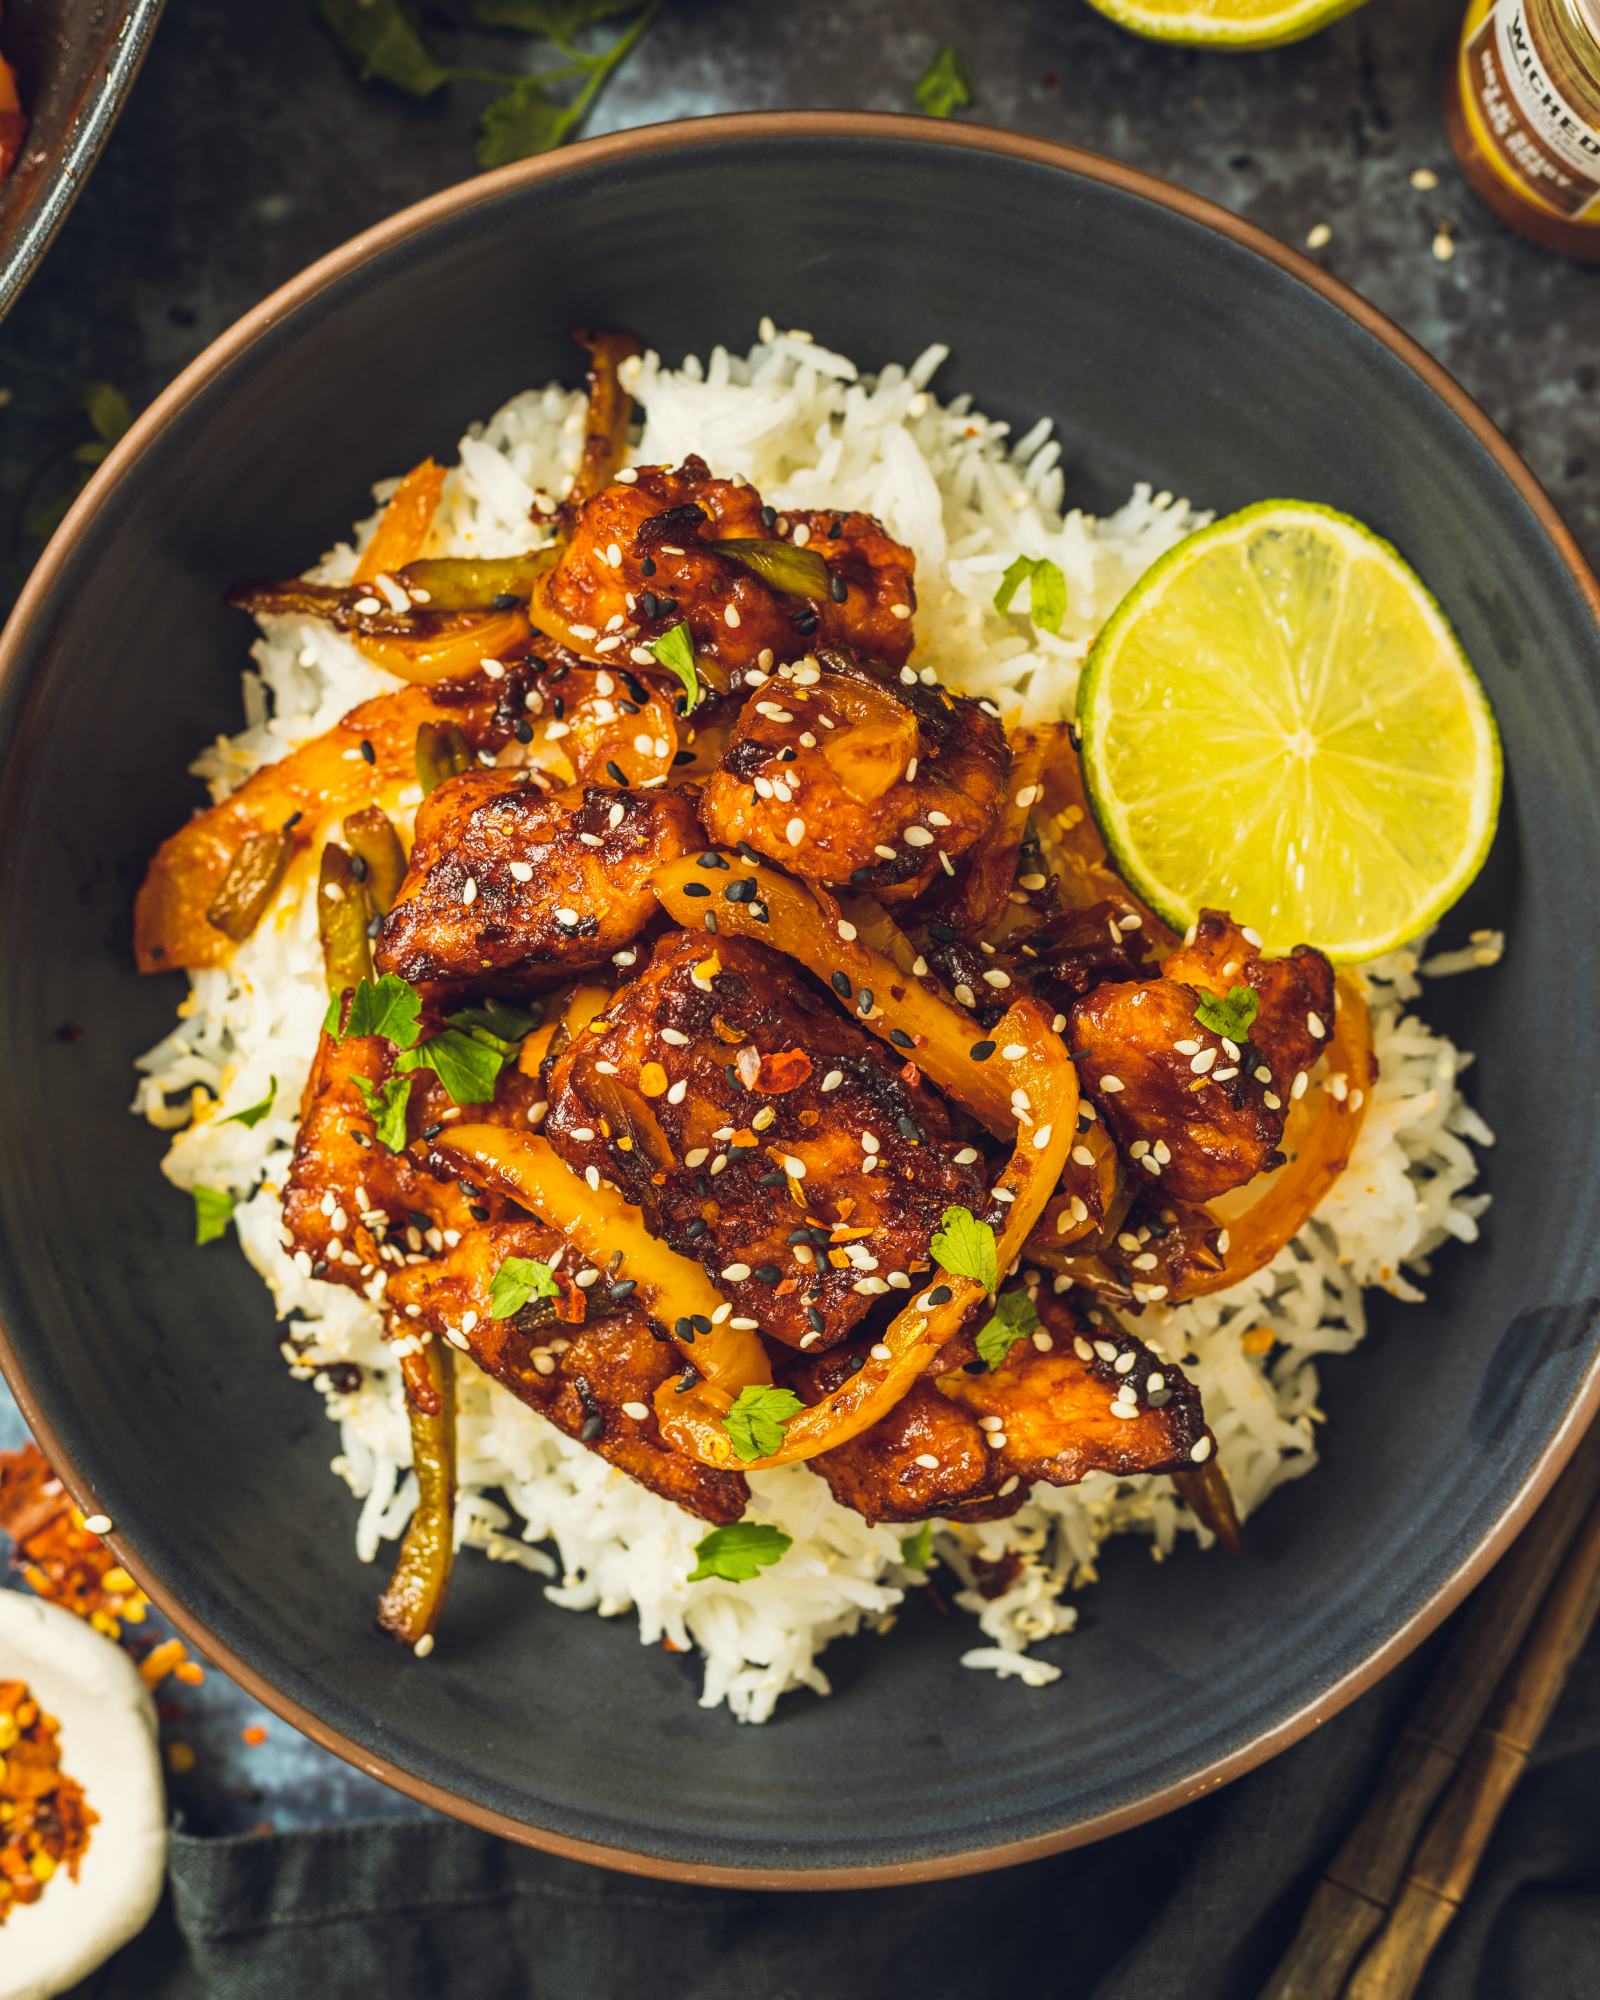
<box><xmin>284</xmin><ymin>1030</ymin><xmax>538</xmax><ymax>1294</ymax></box>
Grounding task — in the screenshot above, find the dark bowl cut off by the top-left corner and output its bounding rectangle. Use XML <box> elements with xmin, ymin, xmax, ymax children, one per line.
<box><xmin>0</xmin><ymin>0</ymin><xmax>162</xmax><ymax>316</ymax></box>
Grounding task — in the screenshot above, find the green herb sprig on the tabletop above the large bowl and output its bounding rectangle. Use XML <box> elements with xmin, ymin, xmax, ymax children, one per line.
<box><xmin>314</xmin><ymin>0</ymin><xmax>660</xmax><ymax>166</ymax></box>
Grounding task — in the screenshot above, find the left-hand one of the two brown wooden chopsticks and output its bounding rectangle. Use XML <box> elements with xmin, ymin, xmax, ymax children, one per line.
<box><xmin>1260</xmin><ymin>1426</ymin><xmax>1600</xmax><ymax>2000</ymax></box>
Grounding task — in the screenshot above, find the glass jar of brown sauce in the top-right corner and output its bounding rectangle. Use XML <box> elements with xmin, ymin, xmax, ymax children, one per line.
<box><xmin>1444</xmin><ymin>0</ymin><xmax>1600</xmax><ymax>262</ymax></box>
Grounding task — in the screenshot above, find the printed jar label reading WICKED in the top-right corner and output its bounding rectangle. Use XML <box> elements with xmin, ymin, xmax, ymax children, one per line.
<box><xmin>1462</xmin><ymin>0</ymin><xmax>1600</xmax><ymax>224</ymax></box>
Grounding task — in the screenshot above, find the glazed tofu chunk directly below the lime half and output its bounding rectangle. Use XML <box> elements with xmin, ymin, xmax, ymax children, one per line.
<box><xmin>1068</xmin><ymin>910</ymin><xmax>1334</xmax><ymax>1202</ymax></box>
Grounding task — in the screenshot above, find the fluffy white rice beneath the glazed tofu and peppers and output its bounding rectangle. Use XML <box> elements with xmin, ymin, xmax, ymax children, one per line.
<box><xmin>134</xmin><ymin>322</ymin><xmax>1500</xmax><ymax>1722</ymax></box>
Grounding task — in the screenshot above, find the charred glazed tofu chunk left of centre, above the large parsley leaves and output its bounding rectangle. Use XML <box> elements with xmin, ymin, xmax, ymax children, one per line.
<box><xmin>372</xmin><ymin>770</ymin><xmax>700</xmax><ymax>986</ymax></box>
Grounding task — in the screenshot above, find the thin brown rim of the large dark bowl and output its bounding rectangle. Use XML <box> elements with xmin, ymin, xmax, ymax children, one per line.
<box><xmin>0</xmin><ymin>112</ymin><xmax>1600</xmax><ymax>1890</ymax></box>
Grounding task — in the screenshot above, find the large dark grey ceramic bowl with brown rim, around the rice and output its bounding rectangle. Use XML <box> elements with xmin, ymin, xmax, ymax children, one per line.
<box><xmin>0</xmin><ymin>116</ymin><xmax>1600</xmax><ymax>1884</ymax></box>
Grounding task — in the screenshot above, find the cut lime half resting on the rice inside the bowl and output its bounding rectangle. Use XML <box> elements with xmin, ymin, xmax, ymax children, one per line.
<box><xmin>1078</xmin><ymin>500</ymin><xmax>1500</xmax><ymax>962</ymax></box>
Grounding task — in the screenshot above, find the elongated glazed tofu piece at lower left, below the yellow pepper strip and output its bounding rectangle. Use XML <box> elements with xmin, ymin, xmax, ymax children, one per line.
<box><xmin>388</xmin><ymin>1220</ymin><xmax>750</xmax><ymax>1522</ymax></box>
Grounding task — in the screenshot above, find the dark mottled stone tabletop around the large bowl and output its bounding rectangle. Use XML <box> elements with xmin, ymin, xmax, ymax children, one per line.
<box><xmin>0</xmin><ymin>0</ymin><xmax>1600</xmax><ymax>1830</ymax></box>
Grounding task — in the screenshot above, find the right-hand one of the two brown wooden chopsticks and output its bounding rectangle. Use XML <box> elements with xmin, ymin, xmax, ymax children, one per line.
<box><xmin>1346</xmin><ymin>1480</ymin><xmax>1600</xmax><ymax>2000</ymax></box>
